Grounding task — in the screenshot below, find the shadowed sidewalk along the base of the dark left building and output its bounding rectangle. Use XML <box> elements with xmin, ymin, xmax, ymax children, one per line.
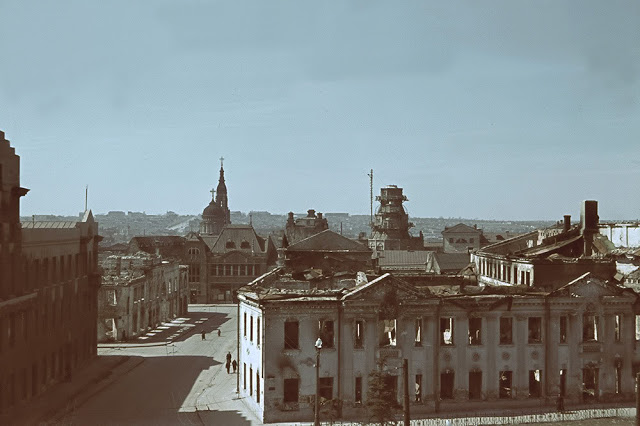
<box><xmin>5</xmin><ymin>356</ymin><xmax>144</xmax><ymax>425</ymax></box>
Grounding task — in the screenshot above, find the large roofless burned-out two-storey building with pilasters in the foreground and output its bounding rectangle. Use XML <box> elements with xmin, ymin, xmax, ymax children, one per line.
<box><xmin>238</xmin><ymin>270</ymin><xmax>640</xmax><ymax>422</ymax></box>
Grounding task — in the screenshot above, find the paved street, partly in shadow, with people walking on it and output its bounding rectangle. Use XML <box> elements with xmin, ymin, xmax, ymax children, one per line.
<box><xmin>60</xmin><ymin>305</ymin><xmax>261</xmax><ymax>426</ymax></box>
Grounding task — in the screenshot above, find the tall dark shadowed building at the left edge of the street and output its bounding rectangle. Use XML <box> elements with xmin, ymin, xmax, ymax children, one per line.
<box><xmin>0</xmin><ymin>132</ymin><xmax>100</xmax><ymax>424</ymax></box>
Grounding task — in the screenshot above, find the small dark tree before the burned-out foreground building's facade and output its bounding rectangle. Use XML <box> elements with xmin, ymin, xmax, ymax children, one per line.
<box><xmin>366</xmin><ymin>360</ymin><xmax>399</xmax><ymax>426</ymax></box>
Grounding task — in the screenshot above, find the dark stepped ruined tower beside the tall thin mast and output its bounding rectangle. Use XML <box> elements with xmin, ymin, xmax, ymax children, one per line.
<box><xmin>369</xmin><ymin>185</ymin><xmax>424</xmax><ymax>251</ymax></box>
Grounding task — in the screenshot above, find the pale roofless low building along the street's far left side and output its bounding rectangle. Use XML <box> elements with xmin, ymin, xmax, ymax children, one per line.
<box><xmin>97</xmin><ymin>252</ymin><xmax>189</xmax><ymax>342</ymax></box>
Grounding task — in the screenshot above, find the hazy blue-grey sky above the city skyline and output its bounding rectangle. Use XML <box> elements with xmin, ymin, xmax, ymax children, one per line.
<box><xmin>0</xmin><ymin>0</ymin><xmax>640</xmax><ymax>219</ymax></box>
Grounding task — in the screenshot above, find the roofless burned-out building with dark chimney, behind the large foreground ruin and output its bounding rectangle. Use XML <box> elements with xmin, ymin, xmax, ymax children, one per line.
<box><xmin>471</xmin><ymin>200</ymin><xmax>616</xmax><ymax>288</ymax></box>
